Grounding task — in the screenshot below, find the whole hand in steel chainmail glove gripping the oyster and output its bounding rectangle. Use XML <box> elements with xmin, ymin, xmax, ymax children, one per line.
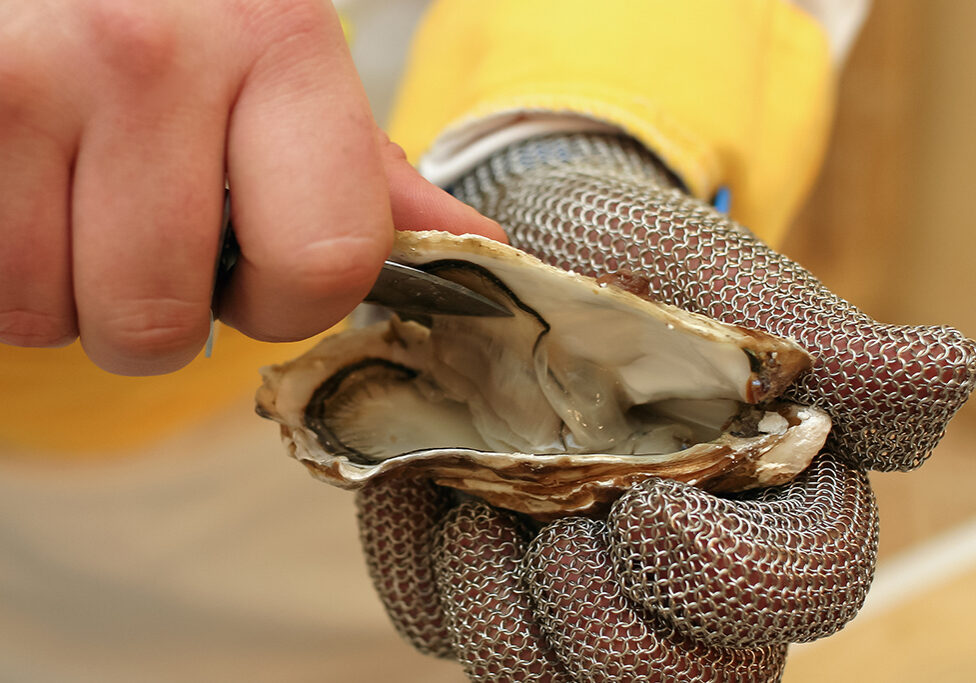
<box><xmin>358</xmin><ymin>131</ymin><xmax>976</xmax><ymax>681</ymax></box>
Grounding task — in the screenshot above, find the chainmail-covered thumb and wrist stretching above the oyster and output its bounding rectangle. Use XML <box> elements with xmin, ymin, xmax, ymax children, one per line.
<box><xmin>454</xmin><ymin>135</ymin><xmax>976</xmax><ymax>470</ymax></box>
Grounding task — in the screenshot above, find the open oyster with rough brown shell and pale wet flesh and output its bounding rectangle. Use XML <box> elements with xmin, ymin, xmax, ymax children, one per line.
<box><xmin>257</xmin><ymin>232</ymin><xmax>830</xmax><ymax>518</ymax></box>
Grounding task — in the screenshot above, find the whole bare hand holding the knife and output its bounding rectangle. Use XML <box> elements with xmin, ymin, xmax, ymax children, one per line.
<box><xmin>0</xmin><ymin>0</ymin><xmax>504</xmax><ymax>374</ymax></box>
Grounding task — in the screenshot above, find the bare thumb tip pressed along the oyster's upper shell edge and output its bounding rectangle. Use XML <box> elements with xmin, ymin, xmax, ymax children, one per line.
<box><xmin>378</xmin><ymin>132</ymin><xmax>508</xmax><ymax>243</ymax></box>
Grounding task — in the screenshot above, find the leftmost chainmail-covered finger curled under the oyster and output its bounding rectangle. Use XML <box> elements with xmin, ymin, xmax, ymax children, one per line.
<box><xmin>356</xmin><ymin>478</ymin><xmax>452</xmax><ymax>657</ymax></box>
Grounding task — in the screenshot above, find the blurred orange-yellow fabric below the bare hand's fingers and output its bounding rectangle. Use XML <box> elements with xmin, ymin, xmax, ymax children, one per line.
<box><xmin>0</xmin><ymin>328</ymin><xmax>322</xmax><ymax>457</ymax></box>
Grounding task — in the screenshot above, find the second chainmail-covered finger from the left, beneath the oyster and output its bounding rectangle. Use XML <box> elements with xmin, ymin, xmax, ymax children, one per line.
<box><xmin>434</xmin><ymin>503</ymin><xmax>570</xmax><ymax>683</ymax></box>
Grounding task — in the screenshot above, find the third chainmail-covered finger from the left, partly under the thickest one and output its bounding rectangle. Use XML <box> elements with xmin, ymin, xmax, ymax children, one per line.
<box><xmin>525</xmin><ymin>517</ymin><xmax>786</xmax><ymax>683</ymax></box>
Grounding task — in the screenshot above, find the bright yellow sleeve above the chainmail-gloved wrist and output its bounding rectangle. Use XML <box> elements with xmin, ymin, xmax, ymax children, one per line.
<box><xmin>391</xmin><ymin>0</ymin><xmax>835</xmax><ymax>248</ymax></box>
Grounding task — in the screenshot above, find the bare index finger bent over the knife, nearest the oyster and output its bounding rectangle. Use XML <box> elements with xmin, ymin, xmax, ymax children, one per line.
<box><xmin>220</xmin><ymin>2</ymin><xmax>393</xmax><ymax>341</ymax></box>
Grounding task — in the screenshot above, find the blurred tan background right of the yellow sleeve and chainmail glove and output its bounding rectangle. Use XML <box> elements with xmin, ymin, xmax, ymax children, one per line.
<box><xmin>784</xmin><ymin>0</ymin><xmax>976</xmax><ymax>683</ymax></box>
